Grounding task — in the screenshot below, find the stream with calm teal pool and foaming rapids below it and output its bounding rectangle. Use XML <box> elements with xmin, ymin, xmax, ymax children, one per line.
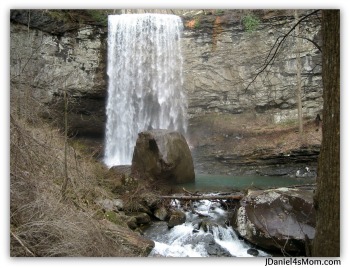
<box><xmin>144</xmin><ymin>175</ymin><xmax>314</xmax><ymax>257</ymax></box>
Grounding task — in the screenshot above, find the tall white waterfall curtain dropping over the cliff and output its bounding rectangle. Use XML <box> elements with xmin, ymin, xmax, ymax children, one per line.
<box><xmin>104</xmin><ymin>14</ymin><xmax>187</xmax><ymax>166</ymax></box>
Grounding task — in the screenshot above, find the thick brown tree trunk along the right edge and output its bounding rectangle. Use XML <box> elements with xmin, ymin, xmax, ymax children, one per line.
<box><xmin>312</xmin><ymin>10</ymin><xmax>340</xmax><ymax>257</ymax></box>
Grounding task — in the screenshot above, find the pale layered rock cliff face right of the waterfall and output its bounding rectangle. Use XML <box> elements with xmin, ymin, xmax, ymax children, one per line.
<box><xmin>183</xmin><ymin>10</ymin><xmax>322</xmax><ymax>122</ymax></box>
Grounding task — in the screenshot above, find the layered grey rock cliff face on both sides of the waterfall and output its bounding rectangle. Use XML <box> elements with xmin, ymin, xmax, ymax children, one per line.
<box><xmin>10</xmin><ymin>10</ymin><xmax>322</xmax><ymax>141</ymax></box>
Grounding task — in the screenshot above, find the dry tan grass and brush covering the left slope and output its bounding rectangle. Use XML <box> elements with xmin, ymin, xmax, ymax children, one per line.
<box><xmin>10</xmin><ymin>117</ymin><xmax>150</xmax><ymax>256</ymax></box>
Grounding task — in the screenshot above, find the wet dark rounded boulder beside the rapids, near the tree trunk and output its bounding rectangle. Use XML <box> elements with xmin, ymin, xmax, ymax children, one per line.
<box><xmin>232</xmin><ymin>188</ymin><xmax>316</xmax><ymax>255</ymax></box>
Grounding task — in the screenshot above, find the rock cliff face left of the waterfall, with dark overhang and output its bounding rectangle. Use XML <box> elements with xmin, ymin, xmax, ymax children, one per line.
<box><xmin>10</xmin><ymin>10</ymin><xmax>107</xmax><ymax>137</ymax></box>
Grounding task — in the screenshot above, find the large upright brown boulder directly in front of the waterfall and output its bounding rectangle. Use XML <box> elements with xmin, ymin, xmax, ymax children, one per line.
<box><xmin>131</xmin><ymin>129</ymin><xmax>195</xmax><ymax>183</ymax></box>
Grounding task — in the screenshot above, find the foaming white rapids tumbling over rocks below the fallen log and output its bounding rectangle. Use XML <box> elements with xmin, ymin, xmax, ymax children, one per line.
<box><xmin>144</xmin><ymin>200</ymin><xmax>270</xmax><ymax>257</ymax></box>
